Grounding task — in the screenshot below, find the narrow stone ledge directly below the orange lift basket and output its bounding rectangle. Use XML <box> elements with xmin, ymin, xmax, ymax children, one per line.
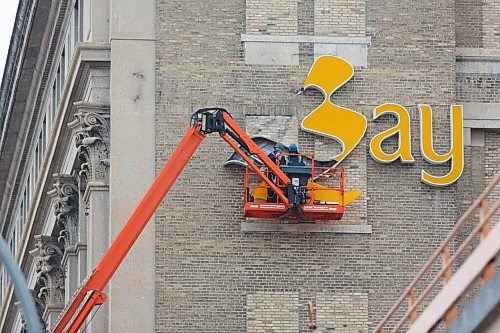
<box><xmin>241</xmin><ymin>222</ymin><xmax>372</xmax><ymax>234</ymax></box>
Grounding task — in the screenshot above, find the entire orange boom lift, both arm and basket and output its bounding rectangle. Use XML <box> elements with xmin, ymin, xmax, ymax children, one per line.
<box><xmin>52</xmin><ymin>108</ymin><xmax>344</xmax><ymax>333</ymax></box>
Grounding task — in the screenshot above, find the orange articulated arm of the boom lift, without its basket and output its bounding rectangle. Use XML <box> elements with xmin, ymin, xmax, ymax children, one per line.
<box><xmin>52</xmin><ymin>108</ymin><xmax>296</xmax><ymax>333</ymax></box>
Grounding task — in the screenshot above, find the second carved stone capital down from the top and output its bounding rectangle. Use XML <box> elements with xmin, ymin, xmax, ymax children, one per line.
<box><xmin>48</xmin><ymin>174</ymin><xmax>79</xmax><ymax>250</ymax></box>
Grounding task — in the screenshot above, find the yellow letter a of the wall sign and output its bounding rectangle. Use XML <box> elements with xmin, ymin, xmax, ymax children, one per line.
<box><xmin>370</xmin><ymin>104</ymin><xmax>415</xmax><ymax>163</ymax></box>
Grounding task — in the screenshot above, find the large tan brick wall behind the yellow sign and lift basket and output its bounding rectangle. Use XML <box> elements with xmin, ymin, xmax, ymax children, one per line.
<box><xmin>156</xmin><ymin>0</ymin><xmax>494</xmax><ymax>332</ymax></box>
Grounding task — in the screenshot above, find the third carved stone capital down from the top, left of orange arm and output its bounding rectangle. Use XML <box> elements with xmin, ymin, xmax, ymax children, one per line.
<box><xmin>30</xmin><ymin>235</ymin><xmax>64</xmax><ymax>307</ymax></box>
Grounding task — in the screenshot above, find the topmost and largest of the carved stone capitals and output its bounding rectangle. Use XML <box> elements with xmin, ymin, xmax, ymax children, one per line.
<box><xmin>68</xmin><ymin>102</ymin><xmax>109</xmax><ymax>183</ymax></box>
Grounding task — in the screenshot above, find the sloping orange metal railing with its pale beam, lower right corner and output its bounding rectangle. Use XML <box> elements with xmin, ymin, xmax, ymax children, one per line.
<box><xmin>373</xmin><ymin>174</ymin><xmax>500</xmax><ymax>333</ymax></box>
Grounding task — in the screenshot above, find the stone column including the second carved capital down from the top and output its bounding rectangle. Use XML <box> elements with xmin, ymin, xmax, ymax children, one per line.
<box><xmin>47</xmin><ymin>174</ymin><xmax>82</xmax><ymax>303</ymax></box>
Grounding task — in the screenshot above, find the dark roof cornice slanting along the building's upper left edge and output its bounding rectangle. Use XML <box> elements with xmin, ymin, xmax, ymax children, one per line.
<box><xmin>0</xmin><ymin>0</ymin><xmax>54</xmax><ymax>234</ymax></box>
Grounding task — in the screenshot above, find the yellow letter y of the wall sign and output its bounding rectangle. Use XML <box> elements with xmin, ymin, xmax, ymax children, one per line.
<box><xmin>418</xmin><ymin>105</ymin><xmax>464</xmax><ymax>186</ymax></box>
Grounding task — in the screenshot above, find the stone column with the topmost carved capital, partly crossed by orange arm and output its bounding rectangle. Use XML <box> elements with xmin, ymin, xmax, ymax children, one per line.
<box><xmin>68</xmin><ymin>102</ymin><xmax>110</xmax><ymax>332</ymax></box>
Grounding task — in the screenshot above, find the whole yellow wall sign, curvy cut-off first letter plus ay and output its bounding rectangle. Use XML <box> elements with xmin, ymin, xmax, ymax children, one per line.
<box><xmin>301</xmin><ymin>56</ymin><xmax>464</xmax><ymax>186</ymax></box>
